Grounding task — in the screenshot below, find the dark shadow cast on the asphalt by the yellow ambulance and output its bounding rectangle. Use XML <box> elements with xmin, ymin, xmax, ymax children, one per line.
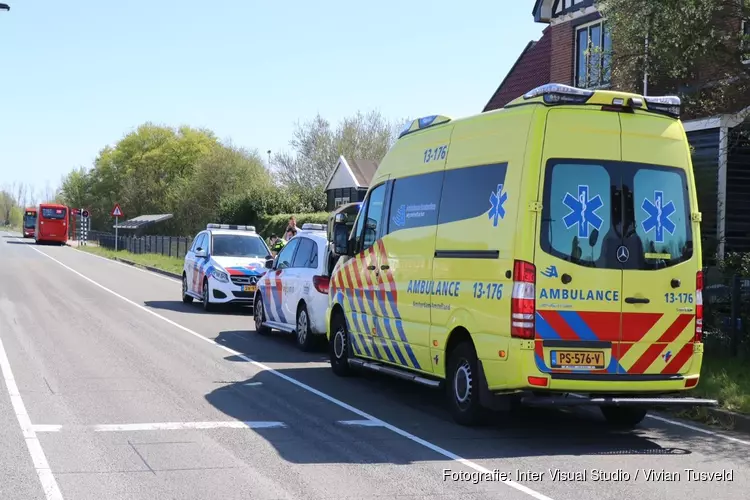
<box><xmin>206</xmin><ymin>330</ymin><xmax>712</xmax><ymax>463</ymax></box>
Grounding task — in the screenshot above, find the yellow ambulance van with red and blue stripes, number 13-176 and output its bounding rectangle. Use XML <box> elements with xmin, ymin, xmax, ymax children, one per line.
<box><xmin>326</xmin><ymin>84</ymin><xmax>716</xmax><ymax>427</ymax></box>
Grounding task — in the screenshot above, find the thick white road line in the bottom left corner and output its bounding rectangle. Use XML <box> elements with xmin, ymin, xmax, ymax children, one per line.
<box><xmin>0</xmin><ymin>340</ymin><xmax>63</xmax><ymax>500</ymax></box>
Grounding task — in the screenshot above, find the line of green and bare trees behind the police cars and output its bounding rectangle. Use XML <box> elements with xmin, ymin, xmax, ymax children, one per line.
<box><xmin>58</xmin><ymin>112</ymin><xmax>405</xmax><ymax>235</ymax></box>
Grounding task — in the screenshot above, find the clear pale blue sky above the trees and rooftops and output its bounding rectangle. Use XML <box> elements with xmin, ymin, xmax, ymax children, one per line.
<box><xmin>0</xmin><ymin>0</ymin><xmax>544</xmax><ymax>201</ymax></box>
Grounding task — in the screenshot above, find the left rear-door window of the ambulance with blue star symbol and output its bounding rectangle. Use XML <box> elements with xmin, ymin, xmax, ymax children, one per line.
<box><xmin>541</xmin><ymin>160</ymin><xmax>619</xmax><ymax>268</ymax></box>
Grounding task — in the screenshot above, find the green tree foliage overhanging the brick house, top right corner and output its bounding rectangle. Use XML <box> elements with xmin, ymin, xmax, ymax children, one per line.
<box><xmin>597</xmin><ymin>0</ymin><xmax>750</xmax><ymax>116</ymax></box>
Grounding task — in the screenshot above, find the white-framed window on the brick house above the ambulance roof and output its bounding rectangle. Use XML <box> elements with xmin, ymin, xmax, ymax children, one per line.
<box><xmin>575</xmin><ymin>21</ymin><xmax>612</xmax><ymax>88</ymax></box>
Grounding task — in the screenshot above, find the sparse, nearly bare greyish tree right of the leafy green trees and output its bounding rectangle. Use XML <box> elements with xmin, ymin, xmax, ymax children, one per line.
<box><xmin>274</xmin><ymin>111</ymin><xmax>406</xmax><ymax>212</ymax></box>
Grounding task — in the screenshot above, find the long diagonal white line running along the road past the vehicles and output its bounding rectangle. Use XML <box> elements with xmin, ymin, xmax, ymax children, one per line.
<box><xmin>29</xmin><ymin>246</ymin><xmax>552</xmax><ymax>500</ymax></box>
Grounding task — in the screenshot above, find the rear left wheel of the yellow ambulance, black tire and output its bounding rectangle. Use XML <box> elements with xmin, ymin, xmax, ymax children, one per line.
<box><xmin>445</xmin><ymin>340</ymin><xmax>487</xmax><ymax>426</ymax></box>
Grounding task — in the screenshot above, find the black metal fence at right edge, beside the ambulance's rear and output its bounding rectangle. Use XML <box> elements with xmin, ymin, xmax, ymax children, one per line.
<box><xmin>703</xmin><ymin>270</ymin><xmax>750</xmax><ymax>357</ymax></box>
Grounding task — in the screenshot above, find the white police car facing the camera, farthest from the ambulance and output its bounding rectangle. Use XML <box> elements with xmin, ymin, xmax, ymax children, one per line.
<box><xmin>182</xmin><ymin>224</ymin><xmax>272</xmax><ymax>310</ymax></box>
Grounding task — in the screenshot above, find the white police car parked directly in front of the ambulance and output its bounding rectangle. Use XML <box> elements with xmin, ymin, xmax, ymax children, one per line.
<box><xmin>254</xmin><ymin>224</ymin><xmax>335</xmax><ymax>351</ymax></box>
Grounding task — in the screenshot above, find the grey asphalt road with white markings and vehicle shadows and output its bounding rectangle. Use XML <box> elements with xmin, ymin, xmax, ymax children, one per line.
<box><xmin>0</xmin><ymin>233</ymin><xmax>750</xmax><ymax>500</ymax></box>
